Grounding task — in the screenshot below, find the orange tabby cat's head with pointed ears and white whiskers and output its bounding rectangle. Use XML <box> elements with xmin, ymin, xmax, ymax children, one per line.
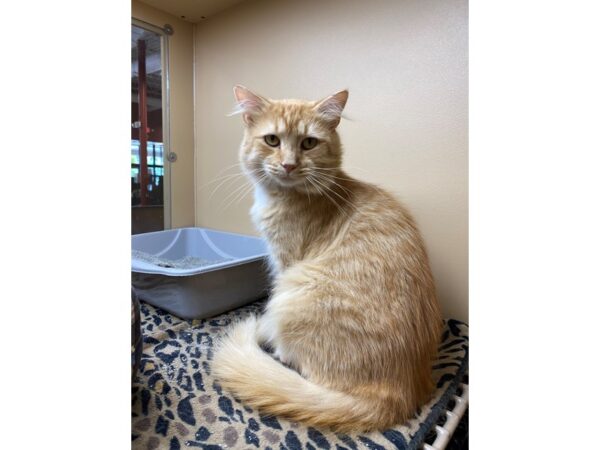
<box><xmin>234</xmin><ymin>86</ymin><xmax>348</xmax><ymax>192</ymax></box>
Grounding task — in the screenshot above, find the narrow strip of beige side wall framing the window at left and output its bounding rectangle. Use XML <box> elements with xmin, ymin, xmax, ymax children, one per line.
<box><xmin>131</xmin><ymin>1</ymin><xmax>195</xmax><ymax>228</ymax></box>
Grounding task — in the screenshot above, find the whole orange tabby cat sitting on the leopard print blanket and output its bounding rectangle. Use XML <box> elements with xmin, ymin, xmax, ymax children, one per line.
<box><xmin>213</xmin><ymin>86</ymin><xmax>442</xmax><ymax>432</ymax></box>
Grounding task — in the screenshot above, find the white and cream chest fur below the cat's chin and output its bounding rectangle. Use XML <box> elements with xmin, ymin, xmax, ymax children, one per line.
<box><xmin>250</xmin><ymin>185</ymin><xmax>310</xmax><ymax>272</ymax></box>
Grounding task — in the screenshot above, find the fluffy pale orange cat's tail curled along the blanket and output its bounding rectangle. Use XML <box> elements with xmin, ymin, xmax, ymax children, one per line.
<box><xmin>212</xmin><ymin>317</ymin><xmax>393</xmax><ymax>432</ymax></box>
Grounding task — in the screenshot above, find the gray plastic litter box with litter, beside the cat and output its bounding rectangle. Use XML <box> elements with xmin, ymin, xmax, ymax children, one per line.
<box><xmin>131</xmin><ymin>228</ymin><xmax>269</xmax><ymax>319</ymax></box>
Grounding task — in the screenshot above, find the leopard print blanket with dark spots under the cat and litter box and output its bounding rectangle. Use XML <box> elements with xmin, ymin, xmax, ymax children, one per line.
<box><xmin>132</xmin><ymin>302</ymin><xmax>468</xmax><ymax>450</ymax></box>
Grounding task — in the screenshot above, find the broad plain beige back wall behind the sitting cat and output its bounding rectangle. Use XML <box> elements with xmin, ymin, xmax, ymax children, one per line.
<box><xmin>195</xmin><ymin>0</ymin><xmax>468</xmax><ymax>320</ymax></box>
